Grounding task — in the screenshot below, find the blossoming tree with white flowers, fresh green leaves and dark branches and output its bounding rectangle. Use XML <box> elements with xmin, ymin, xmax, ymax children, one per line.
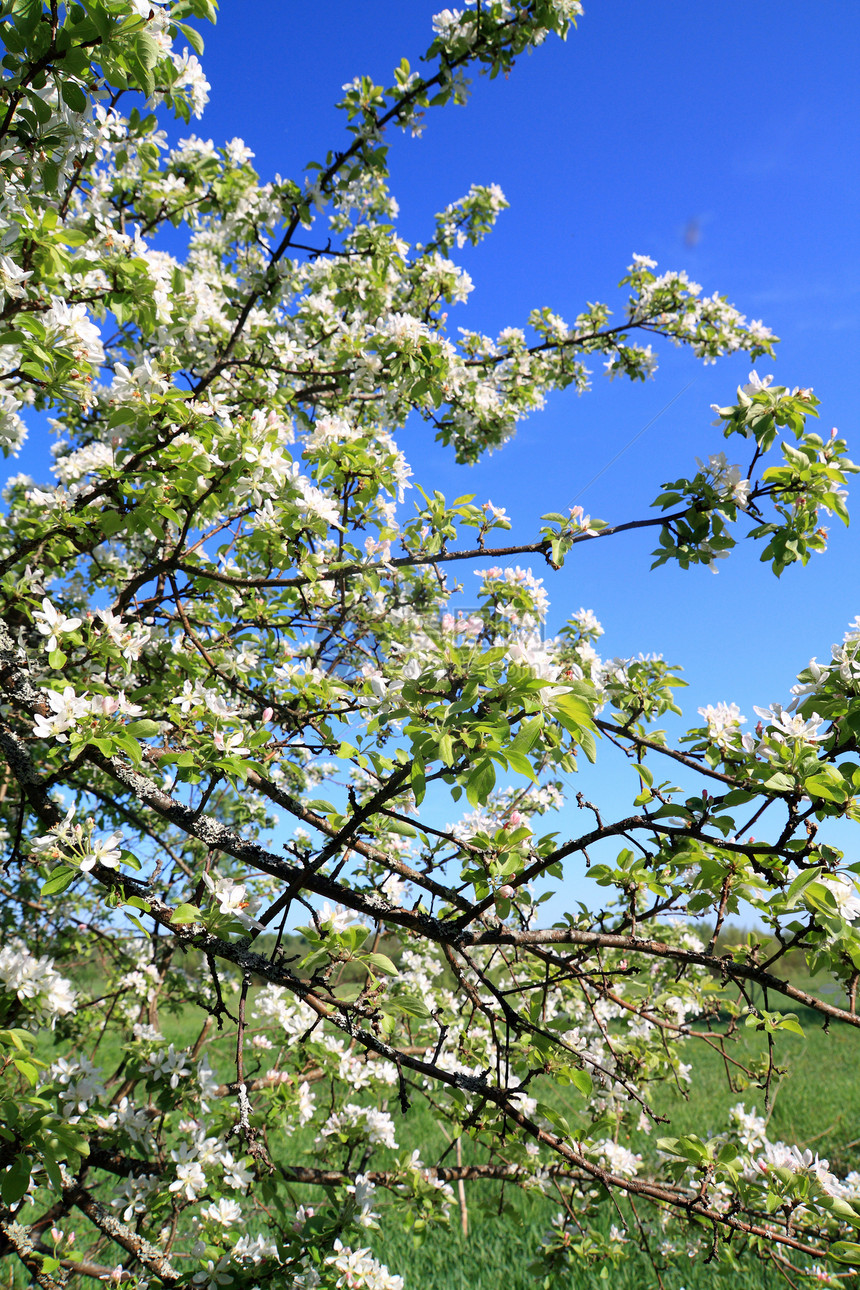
<box><xmin>0</xmin><ymin>0</ymin><xmax>860</xmax><ymax>1290</ymax></box>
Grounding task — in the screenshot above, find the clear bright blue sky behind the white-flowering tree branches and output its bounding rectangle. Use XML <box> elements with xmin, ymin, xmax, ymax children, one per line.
<box><xmin>18</xmin><ymin>0</ymin><xmax>860</xmax><ymax>908</ymax></box>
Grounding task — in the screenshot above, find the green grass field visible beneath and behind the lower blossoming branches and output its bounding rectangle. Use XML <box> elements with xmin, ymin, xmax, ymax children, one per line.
<box><xmin>26</xmin><ymin>975</ymin><xmax>860</xmax><ymax>1290</ymax></box>
